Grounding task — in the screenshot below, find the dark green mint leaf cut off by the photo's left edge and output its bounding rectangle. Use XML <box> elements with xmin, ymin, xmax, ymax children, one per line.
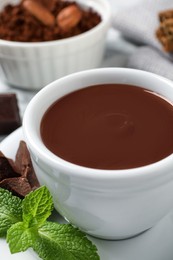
<box><xmin>0</xmin><ymin>188</ymin><xmax>22</xmax><ymax>237</ymax></box>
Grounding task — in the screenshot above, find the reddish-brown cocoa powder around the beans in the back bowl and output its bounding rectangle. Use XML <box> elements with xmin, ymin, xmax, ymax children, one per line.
<box><xmin>0</xmin><ymin>0</ymin><xmax>101</xmax><ymax>42</ymax></box>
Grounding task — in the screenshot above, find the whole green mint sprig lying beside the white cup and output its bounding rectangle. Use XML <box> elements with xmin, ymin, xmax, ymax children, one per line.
<box><xmin>0</xmin><ymin>186</ymin><xmax>100</xmax><ymax>260</ymax></box>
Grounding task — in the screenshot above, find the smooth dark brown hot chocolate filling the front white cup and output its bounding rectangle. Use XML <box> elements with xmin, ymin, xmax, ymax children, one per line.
<box><xmin>40</xmin><ymin>84</ymin><xmax>173</xmax><ymax>169</ymax></box>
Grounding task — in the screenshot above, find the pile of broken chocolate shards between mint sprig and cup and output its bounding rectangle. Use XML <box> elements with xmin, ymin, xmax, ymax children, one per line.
<box><xmin>0</xmin><ymin>141</ymin><xmax>40</xmax><ymax>198</ymax></box>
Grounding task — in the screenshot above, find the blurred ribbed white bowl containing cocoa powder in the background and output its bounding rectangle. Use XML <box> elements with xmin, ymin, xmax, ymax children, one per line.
<box><xmin>0</xmin><ymin>0</ymin><xmax>111</xmax><ymax>89</ymax></box>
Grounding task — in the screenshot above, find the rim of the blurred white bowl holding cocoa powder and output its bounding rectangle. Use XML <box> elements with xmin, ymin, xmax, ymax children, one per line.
<box><xmin>0</xmin><ymin>0</ymin><xmax>111</xmax><ymax>48</ymax></box>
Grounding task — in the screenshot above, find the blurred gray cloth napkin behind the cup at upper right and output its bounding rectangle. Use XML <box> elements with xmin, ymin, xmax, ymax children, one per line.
<box><xmin>112</xmin><ymin>0</ymin><xmax>173</xmax><ymax>80</ymax></box>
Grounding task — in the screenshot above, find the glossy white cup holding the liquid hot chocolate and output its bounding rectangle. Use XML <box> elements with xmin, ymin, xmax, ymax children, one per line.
<box><xmin>23</xmin><ymin>68</ymin><xmax>173</xmax><ymax>239</ymax></box>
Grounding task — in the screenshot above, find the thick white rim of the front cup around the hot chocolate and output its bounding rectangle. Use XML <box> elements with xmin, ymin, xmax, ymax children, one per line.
<box><xmin>23</xmin><ymin>68</ymin><xmax>173</xmax><ymax>180</ymax></box>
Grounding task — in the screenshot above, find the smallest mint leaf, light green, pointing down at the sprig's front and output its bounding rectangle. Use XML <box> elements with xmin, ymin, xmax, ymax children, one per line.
<box><xmin>7</xmin><ymin>222</ymin><xmax>37</xmax><ymax>254</ymax></box>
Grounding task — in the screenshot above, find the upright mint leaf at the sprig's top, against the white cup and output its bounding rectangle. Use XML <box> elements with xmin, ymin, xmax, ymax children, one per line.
<box><xmin>22</xmin><ymin>186</ymin><xmax>53</xmax><ymax>227</ymax></box>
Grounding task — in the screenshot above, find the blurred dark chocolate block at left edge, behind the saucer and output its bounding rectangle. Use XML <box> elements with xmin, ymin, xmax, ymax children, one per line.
<box><xmin>0</xmin><ymin>93</ymin><xmax>21</xmax><ymax>135</ymax></box>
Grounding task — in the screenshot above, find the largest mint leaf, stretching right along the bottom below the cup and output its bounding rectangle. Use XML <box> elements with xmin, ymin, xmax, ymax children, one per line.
<box><xmin>33</xmin><ymin>222</ymin><xmax>100</xmax><ymax>260</ymax></box>
